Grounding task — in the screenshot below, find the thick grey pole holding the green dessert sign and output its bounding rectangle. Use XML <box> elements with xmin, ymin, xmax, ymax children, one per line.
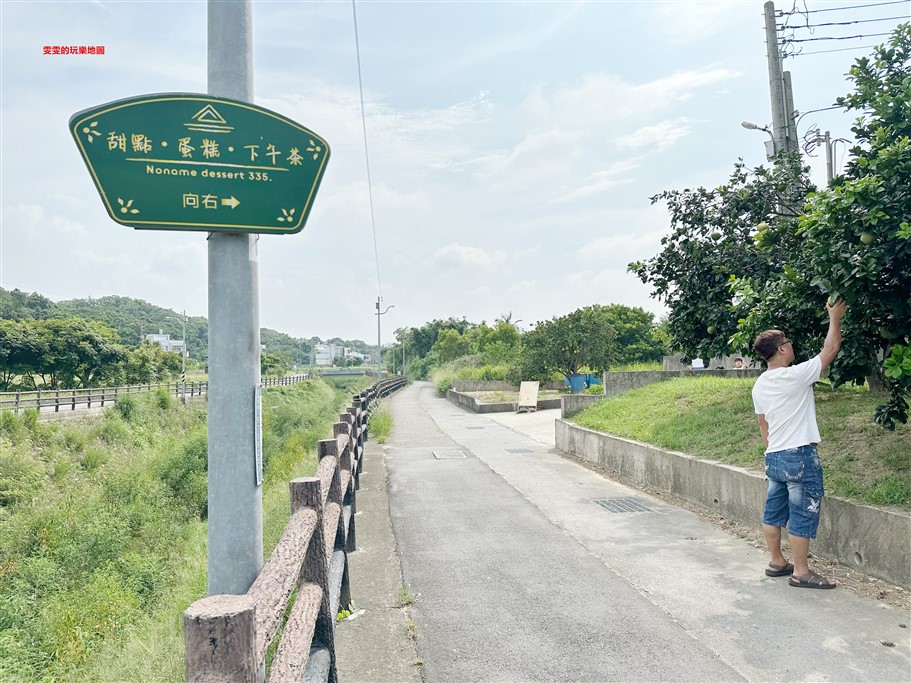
<box><xmin>208</xmin><ymin>0</ymin><xmax>263</xmax><ymax>595</ymax></box>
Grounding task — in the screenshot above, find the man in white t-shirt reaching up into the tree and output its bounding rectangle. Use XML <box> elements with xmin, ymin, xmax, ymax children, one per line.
<box><xmin>753</xmin><ymin>299</ymin><xmax>847</xmax><ymax>588</ymax></box>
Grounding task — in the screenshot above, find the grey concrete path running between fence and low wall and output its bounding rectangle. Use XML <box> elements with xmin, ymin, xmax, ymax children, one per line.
<box><xmin>340</xmin><ymin>383</ymin><xmax>911</xmax><ymax>682</ymax></box>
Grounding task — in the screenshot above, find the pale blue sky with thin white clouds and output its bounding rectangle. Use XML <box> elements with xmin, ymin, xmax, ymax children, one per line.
<box><xmin>0</xmin><ymin>0</ymin><xmax>911</xmax><ymax>344</ymax></box>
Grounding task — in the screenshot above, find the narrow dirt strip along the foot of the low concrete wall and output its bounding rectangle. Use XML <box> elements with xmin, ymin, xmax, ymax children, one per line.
<box><xmin>556</xmin><ymin>451</ymin><xmax>911</xmax><ymax>612</ymax></box>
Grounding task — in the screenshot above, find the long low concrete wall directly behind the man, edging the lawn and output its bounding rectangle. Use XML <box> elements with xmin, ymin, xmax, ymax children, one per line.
<box><xmin>556</xmin><ymin>420</ymin><xmax>911</xmax><ymax>590</ymax></box>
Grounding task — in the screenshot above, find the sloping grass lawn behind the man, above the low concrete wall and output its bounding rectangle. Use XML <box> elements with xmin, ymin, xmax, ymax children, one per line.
<box><xmin>571</xmin><ymin>377</ymin><xmax>911</xmax><ymax>508</ymax></box>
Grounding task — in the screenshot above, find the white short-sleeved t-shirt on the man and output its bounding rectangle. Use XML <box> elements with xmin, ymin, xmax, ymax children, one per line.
<box><xmin>753</xmin><ymin>356</ymin><xmax>822</xmax><ymax>453</ymax></box>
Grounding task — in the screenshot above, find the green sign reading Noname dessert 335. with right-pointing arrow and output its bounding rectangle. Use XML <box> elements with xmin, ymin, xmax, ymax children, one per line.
<box><xmin>70</xmin><ymin>93</ymin><xmax>329</xmax><ymax>235</ymax></box>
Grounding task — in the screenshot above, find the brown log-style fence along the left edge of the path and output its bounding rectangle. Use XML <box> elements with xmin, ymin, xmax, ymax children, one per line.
<box><xmin>183</xmin><ymin>377</ymin><xmax>407</xmax><ymax>683</ymax></box>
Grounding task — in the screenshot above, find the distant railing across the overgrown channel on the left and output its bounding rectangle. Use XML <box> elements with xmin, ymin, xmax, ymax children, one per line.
<box><xmin>0</xmin><ymin>373</ymin><xmax>310</xmax><ymax>414</ymax></box>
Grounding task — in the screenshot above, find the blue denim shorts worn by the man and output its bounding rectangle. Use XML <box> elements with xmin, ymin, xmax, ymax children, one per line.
<box><xmin>762</xmin><ymin>446</ymin><xmax>825</xmax><ymax>538</ymax></box>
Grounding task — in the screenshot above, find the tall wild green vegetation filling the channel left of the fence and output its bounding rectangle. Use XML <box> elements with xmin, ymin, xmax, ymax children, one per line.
<box><xmin>0</xmin><ymin>380</ymin><xmax>370</xmax><ymax>681</ymax></box>
